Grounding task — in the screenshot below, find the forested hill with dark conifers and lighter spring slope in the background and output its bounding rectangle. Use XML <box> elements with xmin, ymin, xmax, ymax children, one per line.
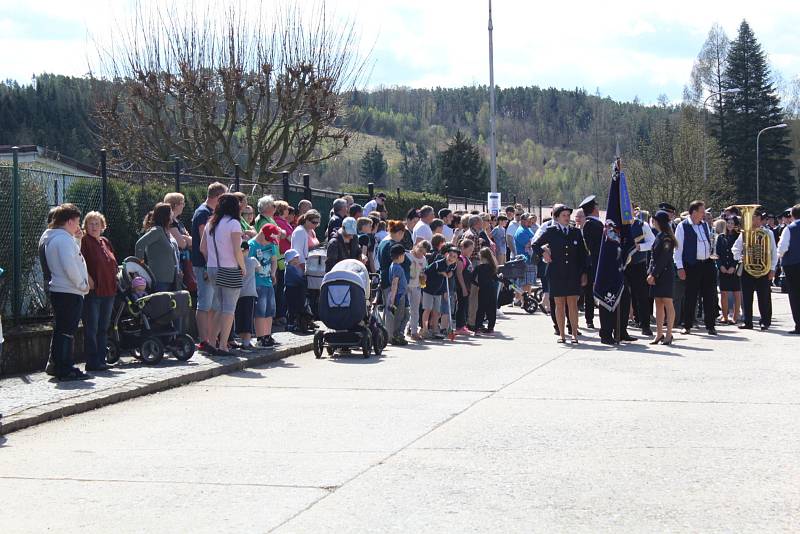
<box><xmin>0</xmin><ymin>74</ymin><xmax>676</xmax><ymax>206</ymax></box>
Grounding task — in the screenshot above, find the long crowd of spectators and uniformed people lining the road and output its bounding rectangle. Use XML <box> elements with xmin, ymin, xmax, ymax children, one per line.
<box><xmin>29</xmin><ymin>183</ymin><xmax>800</xmax><ymax>380</ymax></box>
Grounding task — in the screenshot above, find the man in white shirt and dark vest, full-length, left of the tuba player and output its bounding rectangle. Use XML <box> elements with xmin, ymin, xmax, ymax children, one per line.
<box><xmin>673</xmin><ymin>200</ymin><xmax>717</xmax><ymax>336</ymax></box>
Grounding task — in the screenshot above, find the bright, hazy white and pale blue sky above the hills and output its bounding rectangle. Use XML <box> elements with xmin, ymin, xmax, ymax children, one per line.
<box><xmin>0</xmin><ymin>0</ymin><xmax>800</xmax><ymax>103</ymax></box>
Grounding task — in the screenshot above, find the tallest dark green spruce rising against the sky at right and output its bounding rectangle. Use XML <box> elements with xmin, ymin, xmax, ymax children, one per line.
<box><xmin>720</xmin><ymin>21</ymin><xmax>797</xmax><ymax>210</ymax></box>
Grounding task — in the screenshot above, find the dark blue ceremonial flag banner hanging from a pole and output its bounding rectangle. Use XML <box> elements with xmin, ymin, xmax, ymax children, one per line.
<box><xmin>593</xmin><ymin>160</ymin><xmax>635</xmax><ymax>319</ymax></box>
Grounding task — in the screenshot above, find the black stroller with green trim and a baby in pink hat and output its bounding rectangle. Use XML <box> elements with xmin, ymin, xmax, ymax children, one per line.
<box><xmin>106</xmin><ymin>256</ymin><xmax>194</xmax><ymax>365</ymax></box>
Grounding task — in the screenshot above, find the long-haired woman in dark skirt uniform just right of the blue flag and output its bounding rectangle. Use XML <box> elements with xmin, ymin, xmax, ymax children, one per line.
<box><xmin>647</xmin><ymin>210</ymin><xmax>676</xmax><ymax>345</ymax></box>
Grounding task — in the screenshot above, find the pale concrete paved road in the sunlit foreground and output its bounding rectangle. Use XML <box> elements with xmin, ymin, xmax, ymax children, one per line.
<box><xmin>0</xmin><ymin>294</ymin><xmax>800</xmax><ymax>533</ymax></box>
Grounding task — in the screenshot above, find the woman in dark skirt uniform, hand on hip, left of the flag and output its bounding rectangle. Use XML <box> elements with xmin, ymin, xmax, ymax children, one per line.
<box><xmin>533</xmin><ymin>204</ymin><xmax>589</xmax><ymax>343</ymax></box>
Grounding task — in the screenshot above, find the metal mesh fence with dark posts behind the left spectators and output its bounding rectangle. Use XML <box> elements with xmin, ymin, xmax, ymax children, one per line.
<box><xmin>0</xmin><ymin>148</ymin><xmax>371</xmax><ymax>323</ymax></box>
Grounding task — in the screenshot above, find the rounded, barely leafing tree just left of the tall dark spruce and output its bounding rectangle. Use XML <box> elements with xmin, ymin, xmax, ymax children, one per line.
<box><xmin>627</xmin><ymin>107</ymin><xmax>734</xmax><ymax>216</ymax></box>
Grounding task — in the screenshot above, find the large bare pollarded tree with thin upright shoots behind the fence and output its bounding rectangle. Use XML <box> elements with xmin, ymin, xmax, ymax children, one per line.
<box><xmin>93</xmin><ymin>1</ymin><xmax>367</xmax><ymax>182</ymax></box>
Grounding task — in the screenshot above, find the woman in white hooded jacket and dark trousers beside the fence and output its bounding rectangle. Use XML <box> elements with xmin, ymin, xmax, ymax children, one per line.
<box><xmin>39</xmin><ymin>204</ymin><xmax>91</xmax><ymax>381</ymax></box>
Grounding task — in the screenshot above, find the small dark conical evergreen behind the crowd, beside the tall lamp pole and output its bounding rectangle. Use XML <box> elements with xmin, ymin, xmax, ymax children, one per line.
<box><xmin>437</xmin><ymin>130</ymin><xmax>489</xmax><ymax>198</ymax></box>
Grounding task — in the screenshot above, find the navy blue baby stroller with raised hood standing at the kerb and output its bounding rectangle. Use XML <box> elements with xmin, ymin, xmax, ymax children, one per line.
<box><xmin>314</xmin><ymin>260</ymin><xmax>389</xmax><ymax>358</ymax></box>
